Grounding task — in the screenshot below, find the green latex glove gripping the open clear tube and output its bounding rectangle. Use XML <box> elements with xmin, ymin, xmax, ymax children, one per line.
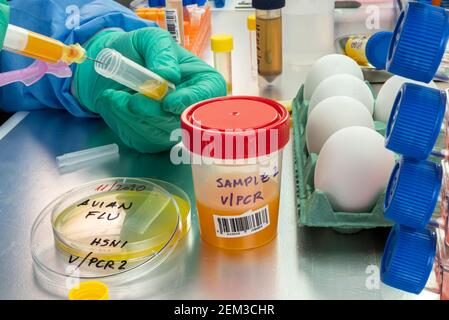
<box><xmin>74</xmin><ymin>27</ymin><xmax>226</xmax><ymax>153</ymax></box>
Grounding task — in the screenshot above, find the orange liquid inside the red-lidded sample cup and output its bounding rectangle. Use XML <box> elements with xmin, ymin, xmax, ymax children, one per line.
<box><xmin>196</xmin><ymin>181</ymin><xmax>280</xmax><ymax>250</ymax></box>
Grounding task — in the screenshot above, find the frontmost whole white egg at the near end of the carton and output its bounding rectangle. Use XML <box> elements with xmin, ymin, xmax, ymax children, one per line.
<box><xmin>315</xmin><ymin>127</ymin><xmax>395</xmax><ymax>212</ymax></box>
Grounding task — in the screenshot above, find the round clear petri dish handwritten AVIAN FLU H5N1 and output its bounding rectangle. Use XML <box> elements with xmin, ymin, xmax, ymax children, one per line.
<box><xmin>31</xmin><ymin>178</ymin><xmax>186</xmax><ymax>290</ymax></box>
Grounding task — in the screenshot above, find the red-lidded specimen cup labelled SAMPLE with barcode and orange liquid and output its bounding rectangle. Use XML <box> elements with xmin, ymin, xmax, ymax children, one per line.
<box><xmin>181</xmin><ymin>96</ymin><xmax>290</xmax><ymax>249</ymax></box>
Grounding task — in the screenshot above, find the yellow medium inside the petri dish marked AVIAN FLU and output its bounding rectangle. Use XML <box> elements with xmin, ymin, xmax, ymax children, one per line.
<box><xmin>52</xmin><ymin>191</ymin><xmax>190</xmax><ymax>261</ymax></box>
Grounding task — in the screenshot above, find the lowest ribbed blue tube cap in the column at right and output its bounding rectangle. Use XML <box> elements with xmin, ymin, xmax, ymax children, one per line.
<box><xmin>380</xmin><ymin>225</ymin><xmax>436</xmax><ymax>294</ymax></box>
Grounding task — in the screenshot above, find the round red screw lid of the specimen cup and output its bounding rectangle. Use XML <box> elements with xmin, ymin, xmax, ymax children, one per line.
<box><xmin>181</xmin><ymin>96</ymin><xmax>290</xmax><ymax>159</ymax></box>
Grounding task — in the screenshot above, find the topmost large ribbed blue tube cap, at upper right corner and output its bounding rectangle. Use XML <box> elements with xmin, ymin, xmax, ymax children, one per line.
<box><xmin>387</xmin><ymin>2</ymin><xmax>449</xmax><ymax>83</ymax></box>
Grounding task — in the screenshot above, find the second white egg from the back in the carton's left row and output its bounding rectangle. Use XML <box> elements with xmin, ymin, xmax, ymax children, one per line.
<box><xmin>309</xmin><ymin>74</ymin><xmax>374</xmax><ymax>114</ymax></box>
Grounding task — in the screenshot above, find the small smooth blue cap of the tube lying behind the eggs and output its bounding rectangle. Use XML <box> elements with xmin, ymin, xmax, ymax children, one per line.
<box><xmin>365</xmin><ymin>31</ymin><xmax>393</xmax><ymax>70</ymax></box>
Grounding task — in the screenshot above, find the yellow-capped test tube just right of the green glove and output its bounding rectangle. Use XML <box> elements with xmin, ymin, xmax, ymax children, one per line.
<box><xmin>211</xmin><ymin>34</ymin><xmax>234</xmax><ymax>94</ymax></box>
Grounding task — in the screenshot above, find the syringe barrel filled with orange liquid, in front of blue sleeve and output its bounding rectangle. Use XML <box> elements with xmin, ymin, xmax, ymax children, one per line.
<box><xmin>3</xmin><ymin>24</ymin><xmax>87</xmax><ymax>64</ymax></box>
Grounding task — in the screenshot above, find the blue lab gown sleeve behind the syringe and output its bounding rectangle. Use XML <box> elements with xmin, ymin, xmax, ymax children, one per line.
<box><xmin>0</xmin><ymin>0</ymin><xmax>155</xmax><ymax>117</ymax></box>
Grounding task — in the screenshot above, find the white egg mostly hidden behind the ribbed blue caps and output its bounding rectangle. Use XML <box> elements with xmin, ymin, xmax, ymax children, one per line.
<box><xmin>374</xmin><ymin>76</ymin><xmax>437</xmax><ymax>123</ymax></box>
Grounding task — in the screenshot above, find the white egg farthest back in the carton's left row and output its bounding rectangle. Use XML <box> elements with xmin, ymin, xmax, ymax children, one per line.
<box><xmin>304</xmin><ymin>54</ymin><xmax>363</xmax><ymax>101</ymax></box>
